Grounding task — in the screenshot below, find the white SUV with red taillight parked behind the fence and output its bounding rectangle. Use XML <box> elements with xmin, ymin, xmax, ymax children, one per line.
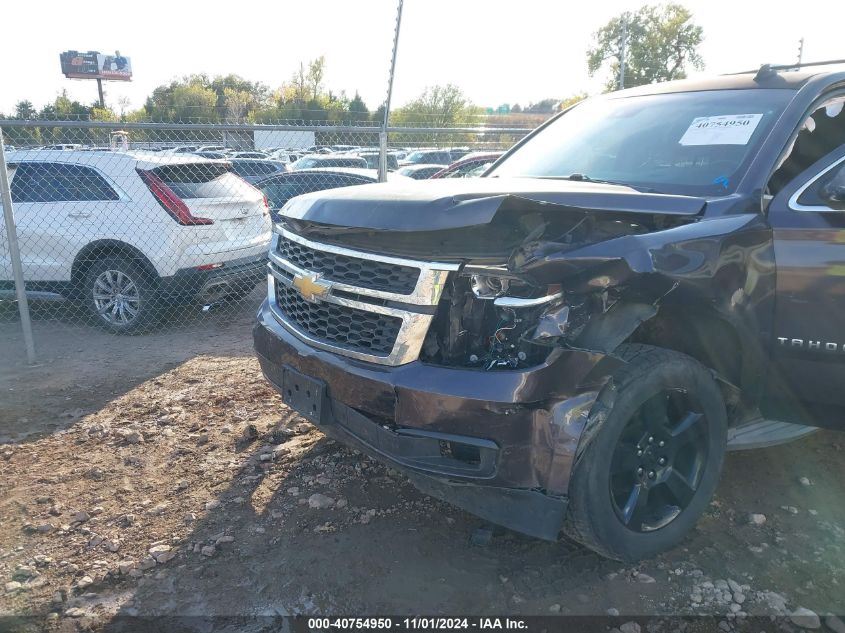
<box><xmin>0</xmin><ymin>151</ymin><xmax>271</xmax><ymax>333</ymax></box>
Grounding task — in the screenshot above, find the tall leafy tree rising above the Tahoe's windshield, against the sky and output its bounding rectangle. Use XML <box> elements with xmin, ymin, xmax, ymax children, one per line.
<box><xmin>587</xmin><ymin>4</ymin><xmax>704</xmax><ymax>90</ymax></box>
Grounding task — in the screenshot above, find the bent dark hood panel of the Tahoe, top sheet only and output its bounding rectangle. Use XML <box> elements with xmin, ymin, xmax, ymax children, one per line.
<box><xmin>282</xmin><ymin>178</ymin><xmax>707</xmax><ymax>232</ymax></box>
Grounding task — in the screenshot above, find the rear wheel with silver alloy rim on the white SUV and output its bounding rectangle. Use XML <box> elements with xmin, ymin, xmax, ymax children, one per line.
<box><xmin>82</xmin><ymin>256</ymin><xmax>159</xmax><ymax>334</ymax></box>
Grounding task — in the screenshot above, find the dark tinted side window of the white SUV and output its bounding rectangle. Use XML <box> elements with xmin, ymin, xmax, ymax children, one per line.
<box><xmin>11</xmin><ymin>163</ymin><xmax>120</xmax><ymax>202</ymax></box>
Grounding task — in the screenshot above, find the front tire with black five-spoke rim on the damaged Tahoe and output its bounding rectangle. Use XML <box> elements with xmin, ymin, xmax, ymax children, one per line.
<box><xmin>564</xmin><ymin>345</ymin><xmax>727</xmax><ymax>562</ymax></box>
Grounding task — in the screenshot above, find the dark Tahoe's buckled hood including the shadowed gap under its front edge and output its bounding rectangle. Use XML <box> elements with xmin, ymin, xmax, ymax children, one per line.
<box><xmin>282</xmin><ymin>178</ymin><xmax>707</xmax><ymax>261</ymax></box>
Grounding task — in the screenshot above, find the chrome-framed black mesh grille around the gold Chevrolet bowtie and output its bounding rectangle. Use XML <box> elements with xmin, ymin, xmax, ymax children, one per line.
<box><xmin>267</xmin><ymin>225</ymin><xmax>458</xmax><ymax>365</ymax></box>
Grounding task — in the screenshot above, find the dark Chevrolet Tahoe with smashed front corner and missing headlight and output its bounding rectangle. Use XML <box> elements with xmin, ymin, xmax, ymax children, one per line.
<box><xmin>254</xmin><ymin>67</ymin><xmax>845</xmax><ymax>560</ymax></box>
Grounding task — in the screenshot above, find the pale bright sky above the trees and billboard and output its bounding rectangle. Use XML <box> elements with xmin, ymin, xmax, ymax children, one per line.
<box><xmin>0</xmin><ymin>0</ymin><xmax>845</xmax><ymax>113</ymax></box>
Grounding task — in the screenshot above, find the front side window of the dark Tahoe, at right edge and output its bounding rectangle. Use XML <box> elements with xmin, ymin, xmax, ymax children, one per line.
<box><xmin>769</xmin><ymin>96</ymin><xmax>845</xmax><ymax>195</ymax></box>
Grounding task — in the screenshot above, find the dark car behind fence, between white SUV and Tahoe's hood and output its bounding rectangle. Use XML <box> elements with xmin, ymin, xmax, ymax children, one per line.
<box><xmin>255</xmin><ymin>167</ymin><xmax>407</xmax><ymax>221</ymax></box>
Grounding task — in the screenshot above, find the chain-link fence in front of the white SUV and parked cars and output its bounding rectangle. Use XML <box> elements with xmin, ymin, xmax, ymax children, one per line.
<box><xmin>0</xmin><ymin>121</ymin><xmax>530</xmax><ymax>360</ymax></box>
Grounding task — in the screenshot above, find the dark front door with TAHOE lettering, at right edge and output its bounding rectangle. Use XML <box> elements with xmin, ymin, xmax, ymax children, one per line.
<box><xmin>765</xmin><ymin>145</ymin><xmax>845</xmax><ymax>427</ymax></box>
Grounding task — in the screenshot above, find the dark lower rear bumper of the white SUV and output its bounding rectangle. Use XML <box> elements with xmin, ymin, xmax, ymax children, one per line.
<box><xmin>159</xmin><ymin>253</ymin><xmax>267</xmax><ymax>303</ymax></box>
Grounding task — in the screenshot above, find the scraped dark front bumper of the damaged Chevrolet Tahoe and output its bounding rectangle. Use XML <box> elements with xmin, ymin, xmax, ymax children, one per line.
<box><xmin>253</xmin><ymin>302</ymin><xmax>616</xmax><ymax>540</ymax></box>
